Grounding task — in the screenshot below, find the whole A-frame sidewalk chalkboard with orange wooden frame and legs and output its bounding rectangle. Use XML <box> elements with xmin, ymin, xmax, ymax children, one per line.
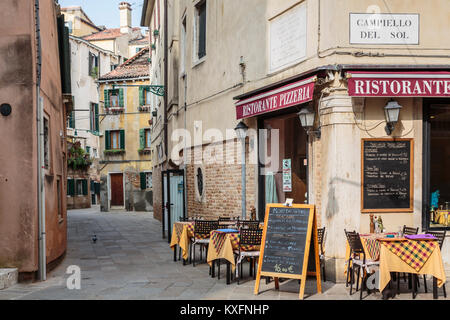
<box><xmin>255</xmin><ymin>204</ymin><xmax>322</xmax><ymax>299</ymax></box>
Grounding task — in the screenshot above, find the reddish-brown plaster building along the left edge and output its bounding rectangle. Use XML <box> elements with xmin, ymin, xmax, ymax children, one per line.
<box><xmin>0</xmin><ymin>0</ymin><xmax>71</xmax><ymax>279</ymax></box>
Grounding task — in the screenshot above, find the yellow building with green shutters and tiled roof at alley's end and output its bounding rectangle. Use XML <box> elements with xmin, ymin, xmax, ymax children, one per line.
<box><xmin>98</xmin><ymin>48</ymin><xmax>153</xmax><ymax>211</ymax></box>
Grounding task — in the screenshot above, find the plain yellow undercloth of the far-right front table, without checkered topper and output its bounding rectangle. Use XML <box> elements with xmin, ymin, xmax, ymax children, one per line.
<box><xmin>379</xmin><ymin>240</ymin><xmax>446</xmax><ymax>291</ymax></box>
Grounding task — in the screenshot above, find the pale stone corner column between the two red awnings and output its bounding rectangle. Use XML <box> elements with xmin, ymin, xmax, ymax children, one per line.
<box><xmin>315</xmin><ymin>76</ymin><xmax>361</xmax><ymax>282</ymax></box>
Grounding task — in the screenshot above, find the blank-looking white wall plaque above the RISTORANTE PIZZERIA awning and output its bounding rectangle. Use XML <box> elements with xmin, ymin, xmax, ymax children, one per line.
<box><xmin>269</xmin><ymin>2</ymin><xmax>306</xmax><ymax>73</ymax></box>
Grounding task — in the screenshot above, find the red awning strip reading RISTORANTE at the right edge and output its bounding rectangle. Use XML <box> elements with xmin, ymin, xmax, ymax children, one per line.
<box><xmin>347</xmin><ymin>71</ymin><xmax>450</xmax><ymax>97</ymax></box>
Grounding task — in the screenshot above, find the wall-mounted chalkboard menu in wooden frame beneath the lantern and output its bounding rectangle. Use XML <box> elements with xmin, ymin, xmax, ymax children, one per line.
<box><xmin>361</xmin><ymin>139</ymin><xmax>414</xmax><ymax>212</ymax></box>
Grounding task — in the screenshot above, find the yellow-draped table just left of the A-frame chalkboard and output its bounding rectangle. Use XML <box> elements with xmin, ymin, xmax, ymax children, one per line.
<box><xmin>206</xmin><ymin>229</ymin><xmax>259</xmax><ymax>284</ymax></box>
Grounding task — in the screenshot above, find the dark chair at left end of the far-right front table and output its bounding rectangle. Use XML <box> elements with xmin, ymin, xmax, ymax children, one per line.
<box><xmin>347</xmin><ymin>233</ymin><xmax>380</xmax><ymax>300</ymax></box>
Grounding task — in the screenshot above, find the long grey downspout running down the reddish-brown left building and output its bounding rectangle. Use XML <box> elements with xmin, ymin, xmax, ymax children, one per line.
<box><xmin>35</xmin><ymin>0</ymin><xmax>47</xmax><ymax>281</ymax></box>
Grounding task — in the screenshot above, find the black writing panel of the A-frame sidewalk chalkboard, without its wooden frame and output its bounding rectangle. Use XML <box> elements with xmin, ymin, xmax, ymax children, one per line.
<box><xmin>262</xmin><ymin>207</ymin><xmax>309</xmax><ymax>274</ymax></box>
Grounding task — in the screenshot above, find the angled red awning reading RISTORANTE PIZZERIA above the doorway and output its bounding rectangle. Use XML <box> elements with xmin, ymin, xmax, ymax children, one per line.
<box><xmin>236</xmin><ymin>76</ymin><xmax>317</xmax><ymax>120</ymax></box>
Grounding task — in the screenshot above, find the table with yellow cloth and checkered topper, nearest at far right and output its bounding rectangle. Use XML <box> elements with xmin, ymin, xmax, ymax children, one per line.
<box><xmin>379</xmin><ymin>238</ymin><xmax>446</xmax><ymax>299</ymax></box>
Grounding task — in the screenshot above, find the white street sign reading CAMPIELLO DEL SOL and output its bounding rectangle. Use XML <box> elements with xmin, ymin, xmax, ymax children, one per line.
<box><xmin>349</xmin><ymin>13</ymin><xmax>419</xmax><ymax>44</ymax></box>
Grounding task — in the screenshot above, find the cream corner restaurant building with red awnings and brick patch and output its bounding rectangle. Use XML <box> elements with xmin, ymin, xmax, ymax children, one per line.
<box><xmin>142</xmin><ymin>0</ymin><xmax>450</xmax><ymax>282</ymax></box>
